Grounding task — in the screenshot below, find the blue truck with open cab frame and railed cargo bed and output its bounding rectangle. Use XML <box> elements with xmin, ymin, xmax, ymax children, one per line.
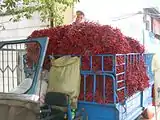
<box><xmin>0</xmin><ymin>38</ymin><xmax>154</xmax><ymax>120</ymax></box>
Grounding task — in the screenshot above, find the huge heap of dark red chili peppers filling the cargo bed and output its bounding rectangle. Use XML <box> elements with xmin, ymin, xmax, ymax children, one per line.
<box><xmin>27</xmin><ymin>22</ymin><xmax>149</xmax><ymax>103</ymax></box>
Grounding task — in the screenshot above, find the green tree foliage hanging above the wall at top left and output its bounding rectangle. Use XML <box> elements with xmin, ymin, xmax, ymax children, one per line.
<box><xmin>0</xmin><ymin>0</ymin><xmax>79</xmax><ymax>27</ymax></box>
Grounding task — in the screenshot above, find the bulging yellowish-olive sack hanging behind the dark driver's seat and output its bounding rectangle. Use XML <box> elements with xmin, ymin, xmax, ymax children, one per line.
<box><xmin>48</xmin><ymin>56</ymin><xmax>81</xmax><ymax>108</ymax></box>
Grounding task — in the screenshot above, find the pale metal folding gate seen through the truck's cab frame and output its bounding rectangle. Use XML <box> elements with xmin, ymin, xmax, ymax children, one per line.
<box><xmin>0</xmin><ymin>44</ymin><xmax>25</xmax><ymax>92</ymax></box>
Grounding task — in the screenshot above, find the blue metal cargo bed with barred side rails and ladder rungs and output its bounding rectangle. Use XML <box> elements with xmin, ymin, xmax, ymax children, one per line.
<box><xmin>78</xmin><ymin>53</ymin><xmax>154</xmax><ymax>120</ymax></box>
